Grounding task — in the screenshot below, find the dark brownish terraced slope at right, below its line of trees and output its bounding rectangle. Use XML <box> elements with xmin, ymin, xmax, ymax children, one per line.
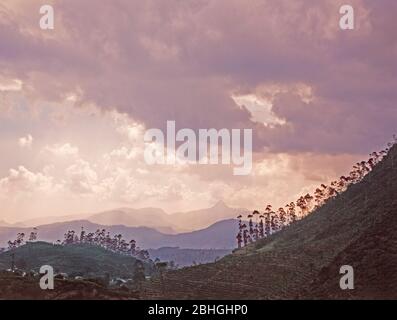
<box><xmin>146</xmin><ymin>146</ymin><xmax>397</xmax><ymax>299</ymax></box>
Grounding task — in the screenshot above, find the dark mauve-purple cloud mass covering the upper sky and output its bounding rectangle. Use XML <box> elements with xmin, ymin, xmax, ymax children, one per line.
<box><xmin>0</xmin><ymin>0</ymin><xmax>397</xmax><ymax>152</ymax></box>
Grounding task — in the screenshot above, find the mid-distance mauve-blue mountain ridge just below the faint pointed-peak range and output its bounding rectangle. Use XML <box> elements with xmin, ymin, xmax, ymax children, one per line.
<box><xmin>0</xmin><ymin>219</ymin><xmax>237</xmax><ymax>249</ymax></box>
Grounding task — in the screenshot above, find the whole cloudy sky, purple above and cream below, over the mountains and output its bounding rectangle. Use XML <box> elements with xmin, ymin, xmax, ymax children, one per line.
<box><xmin>0</xmin><ymin>0</ymin><xmax>397</xmax><ymax>222</ymax></box>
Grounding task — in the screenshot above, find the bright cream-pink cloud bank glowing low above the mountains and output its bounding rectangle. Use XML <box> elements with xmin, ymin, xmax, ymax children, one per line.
<box><xmin>0</xmin><ymin>105</ymin><xmax>372</xmax><ymax>220</ymax></box>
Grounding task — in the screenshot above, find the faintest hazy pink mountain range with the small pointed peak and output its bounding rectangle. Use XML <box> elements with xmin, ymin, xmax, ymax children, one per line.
<box><xmin>14</xmin><ymin>201</ymin><xmax>244</xmax><ymax>234</ymax></box>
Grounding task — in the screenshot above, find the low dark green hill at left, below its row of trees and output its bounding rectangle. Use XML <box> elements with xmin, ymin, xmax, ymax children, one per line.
<box><xmin>0</xmin><ymin>242</ymin><xmax>152</xmax><ymax>278</ymax></box>
